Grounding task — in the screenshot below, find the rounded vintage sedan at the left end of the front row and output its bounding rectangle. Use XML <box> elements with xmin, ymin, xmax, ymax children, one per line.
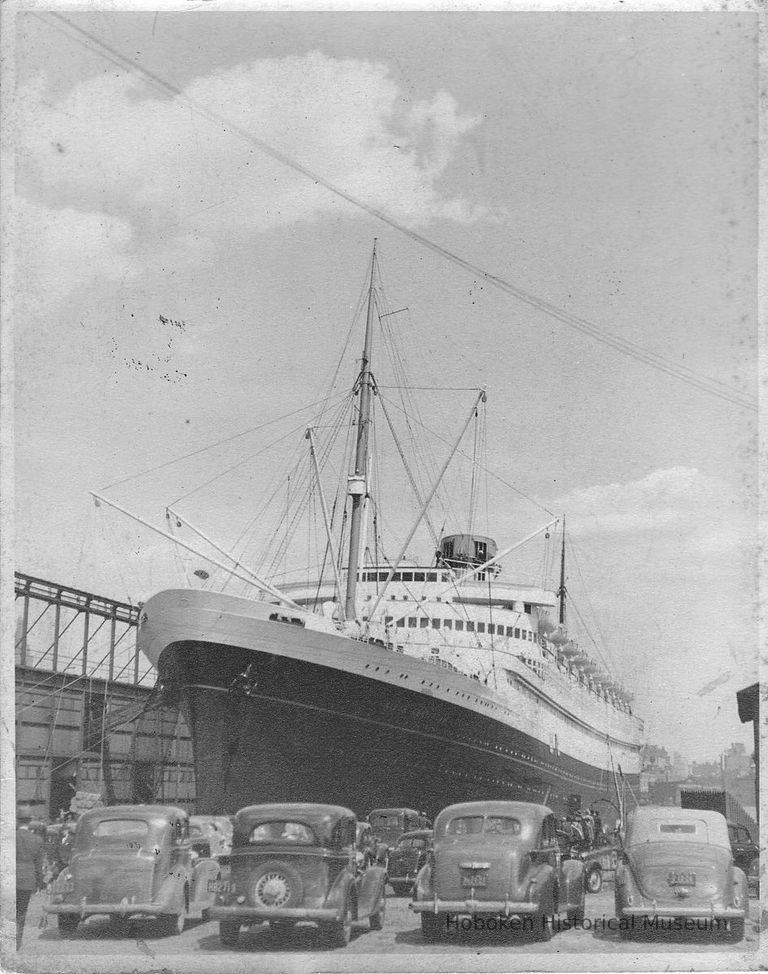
<box><xmin>45</xmin><ymin>805</ymin><xmax>220</xmax><ymax>936</ymax></box>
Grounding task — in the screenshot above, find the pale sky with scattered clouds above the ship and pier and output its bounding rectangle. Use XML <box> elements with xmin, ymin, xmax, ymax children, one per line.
<box><xmin>13</xmin><ymin>9</ymin><xmax>758</xmax><ymax>772</ymax></box>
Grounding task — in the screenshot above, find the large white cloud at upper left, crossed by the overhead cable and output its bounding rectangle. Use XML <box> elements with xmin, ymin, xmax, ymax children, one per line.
<box><xmin>19</xmin><ymin>52</ymin><xmax>481</xmax><ymax>243</ymax></box>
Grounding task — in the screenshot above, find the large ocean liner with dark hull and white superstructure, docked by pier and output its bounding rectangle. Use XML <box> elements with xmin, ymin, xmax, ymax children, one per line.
<box><xmin>139</xmin><ymin>245</ymin><xmax>642</xmax><ymax>815</ymax></box>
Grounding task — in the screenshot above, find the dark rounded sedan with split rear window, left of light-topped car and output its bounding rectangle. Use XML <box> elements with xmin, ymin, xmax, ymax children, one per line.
<box><xmin>410</xmin><ymin>801</ymin><xmax>584</xmax><ymax>941</ymax></box>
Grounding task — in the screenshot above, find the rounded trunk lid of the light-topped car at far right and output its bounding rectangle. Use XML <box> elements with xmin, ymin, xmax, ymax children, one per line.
<box><xmin>627</xmin><ymin>842</ymin><xmax>731</xmax><ymax>905</ymax></box>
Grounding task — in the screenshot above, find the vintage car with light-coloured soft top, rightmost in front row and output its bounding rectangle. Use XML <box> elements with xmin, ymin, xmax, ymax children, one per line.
<box><xmin>614</xmin><ymin>806</ymin><xmax>748</xmax><ymax>941</ymax></box>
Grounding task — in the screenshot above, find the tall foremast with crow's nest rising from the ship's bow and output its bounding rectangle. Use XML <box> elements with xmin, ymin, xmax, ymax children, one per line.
<box><xmin>344</xmin><ymin>238</ymin><xmax>376</xmax><ymax>619</ymax></box>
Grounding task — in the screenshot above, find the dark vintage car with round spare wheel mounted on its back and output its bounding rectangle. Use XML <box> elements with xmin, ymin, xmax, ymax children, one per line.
<box><xmin>210</xmin><ymin>804</ymin><xmax>386</xmax><ymax>947</ymax></box>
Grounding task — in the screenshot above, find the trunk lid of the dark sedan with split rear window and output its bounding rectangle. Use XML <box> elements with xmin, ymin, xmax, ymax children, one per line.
<box><xmin>433</xmin><ymin>843</ymin><xmax>528</xmax><ymax>900</ymax></box>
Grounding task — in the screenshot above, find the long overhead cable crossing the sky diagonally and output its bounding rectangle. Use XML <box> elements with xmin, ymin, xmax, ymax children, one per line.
<box><xmin>42</xmin><ymin>12</ymin><xmax>757</xmax><ymax>416</ymax></box>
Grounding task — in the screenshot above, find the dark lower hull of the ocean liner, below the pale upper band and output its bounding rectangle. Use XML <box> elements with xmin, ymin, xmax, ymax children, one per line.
<box><xmin>158</xmin><ymin>640</ymin><xmax>638</xmax><ymax>817</ymax></box>
